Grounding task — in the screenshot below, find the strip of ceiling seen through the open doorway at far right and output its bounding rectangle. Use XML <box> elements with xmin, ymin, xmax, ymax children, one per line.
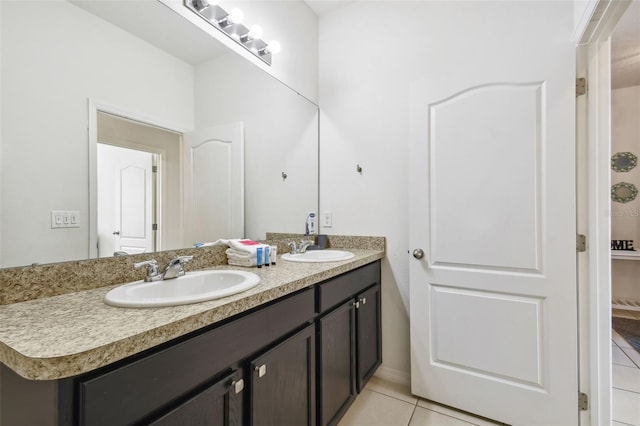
<box><xmin>611</xmin><ymin>0</ymin><xmax>640</xmax><ymax>89</ymax></box>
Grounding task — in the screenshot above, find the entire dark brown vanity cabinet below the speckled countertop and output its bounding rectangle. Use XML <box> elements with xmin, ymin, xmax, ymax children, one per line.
<box><xmin>0</xmin><ymin>261</ymin><xmax>381</xmax><ymax>426</ymax></box>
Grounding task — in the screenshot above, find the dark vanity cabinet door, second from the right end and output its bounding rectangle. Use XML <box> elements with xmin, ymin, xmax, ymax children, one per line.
<box><xmin>318</xmin><ymin>299</ymin><xmax>356</xmax><ymax>425</ymax></box>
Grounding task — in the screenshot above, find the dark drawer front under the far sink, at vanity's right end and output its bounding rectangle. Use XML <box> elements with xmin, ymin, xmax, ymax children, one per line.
<box><xmin>318</xmin><ymin>261</ymin><xmax>380</xmax><ymax>312</ymax></box>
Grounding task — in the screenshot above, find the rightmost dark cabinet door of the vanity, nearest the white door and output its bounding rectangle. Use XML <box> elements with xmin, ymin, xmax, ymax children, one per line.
<box><xmin>356</xmin><ymin>284</ymin><xmax>382</xmax><ymax>393</ymax></box>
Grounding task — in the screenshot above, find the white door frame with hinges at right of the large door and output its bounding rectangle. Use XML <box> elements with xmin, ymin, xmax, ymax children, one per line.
<box><xmin>576</xmin><ymin>0</ymin><xmax>631</xmax><ymax>425</ymax></box>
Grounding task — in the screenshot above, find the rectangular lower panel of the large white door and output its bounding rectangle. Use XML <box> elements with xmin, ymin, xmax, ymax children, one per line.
<box><xmin>429</xmin><ymin>285</ymin><xmax>544</xmax><ymax>387</ymax></box>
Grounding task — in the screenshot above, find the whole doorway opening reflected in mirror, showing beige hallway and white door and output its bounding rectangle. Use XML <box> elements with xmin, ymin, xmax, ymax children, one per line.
<box><xmin>94</xmin><ymin>111</ymin><xmax>183</xmax><ymax>257</ymax></box>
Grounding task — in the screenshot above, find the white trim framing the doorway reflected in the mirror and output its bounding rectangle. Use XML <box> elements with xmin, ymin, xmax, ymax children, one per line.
<box><xmin>87</xmin><ymin>98</ymin><xmax>189</xmax><ymax>259</ymax></box>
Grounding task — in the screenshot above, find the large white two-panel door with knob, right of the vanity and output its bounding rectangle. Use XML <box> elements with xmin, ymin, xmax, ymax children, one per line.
<box><xmin>409</xmin><ymin>2</ymin><xmax>578</xmax><ymax>425</ymax></box>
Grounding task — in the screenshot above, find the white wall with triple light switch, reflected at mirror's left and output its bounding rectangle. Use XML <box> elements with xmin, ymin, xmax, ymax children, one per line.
<box><xmin>0</xmin><ymin>1</ymin><xmax>193</xmax><ymax>266</ymax></box>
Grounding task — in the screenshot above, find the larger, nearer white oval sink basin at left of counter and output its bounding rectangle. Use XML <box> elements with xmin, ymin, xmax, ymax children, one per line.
<box><xmin>104</xmin><ymin>270</ymin><xmax>260</xmax><ymax>308</ymax></box>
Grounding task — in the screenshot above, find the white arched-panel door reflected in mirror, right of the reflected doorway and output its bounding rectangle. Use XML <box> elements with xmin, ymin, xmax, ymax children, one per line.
<box><xmin>185</xmin><ymin>122</ymin><xmax>244</xmax><ymax>244</ymax></box>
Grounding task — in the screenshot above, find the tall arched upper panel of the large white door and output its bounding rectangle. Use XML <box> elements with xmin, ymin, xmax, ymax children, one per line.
<box><xmin>428</xmin><ymin>82</ymin><xmax>544</xmax><ymax>272</ymax></box>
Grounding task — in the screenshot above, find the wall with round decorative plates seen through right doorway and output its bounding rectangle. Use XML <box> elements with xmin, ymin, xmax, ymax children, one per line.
<box><xmin>611</xmin><ymin>86</ymin><xmax>640</xmax><ymax>305</ymax></box>
